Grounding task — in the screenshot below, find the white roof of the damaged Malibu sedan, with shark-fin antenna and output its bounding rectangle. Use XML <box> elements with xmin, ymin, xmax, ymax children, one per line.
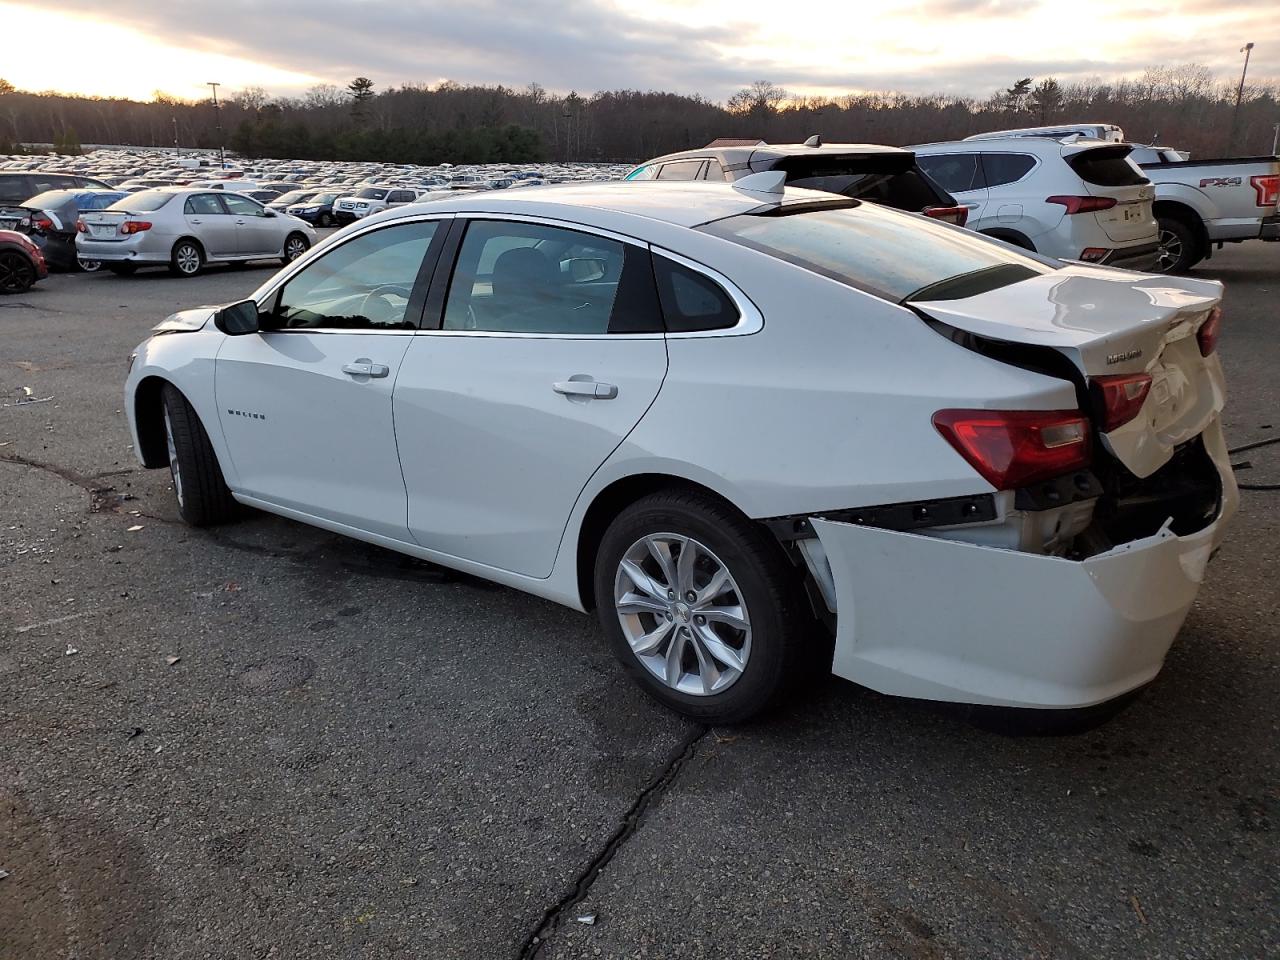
<box><xmin>378</xmin><ymin>180</ymin><xmax>849</xmax><ymax>229</ymax></box>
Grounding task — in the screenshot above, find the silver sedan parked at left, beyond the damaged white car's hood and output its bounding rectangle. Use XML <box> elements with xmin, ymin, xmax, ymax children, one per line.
<box><xmin>76</xmin><ymin>188</ymin><xmax>316</xmax><ymax>276</ymax></box>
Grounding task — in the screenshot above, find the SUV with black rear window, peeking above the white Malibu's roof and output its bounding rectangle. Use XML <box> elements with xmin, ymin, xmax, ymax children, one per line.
<box><xmin>625</xmin><ymin>137</ymin><xmax>969</xmax><ymax>227</ymax></box>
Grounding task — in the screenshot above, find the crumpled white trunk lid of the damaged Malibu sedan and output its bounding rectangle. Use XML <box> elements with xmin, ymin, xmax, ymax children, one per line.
<box><xmin>911</xmin><ymin>266</ymin><xmax>1225</xmax><ymax>477</ymax></box>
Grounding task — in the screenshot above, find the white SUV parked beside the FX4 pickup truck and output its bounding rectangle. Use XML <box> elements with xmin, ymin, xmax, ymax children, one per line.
<box><xmin>913</xmin><ymin>136</ymin><xmax>1158</xmax><ymax>270</ymax></box>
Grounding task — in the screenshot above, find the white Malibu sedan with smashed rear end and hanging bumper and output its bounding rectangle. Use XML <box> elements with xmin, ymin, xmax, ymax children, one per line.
<box><xmin>125</xmin><ymin>173</ymin><xmax>1238</xmax><ymax>722</ymax></box>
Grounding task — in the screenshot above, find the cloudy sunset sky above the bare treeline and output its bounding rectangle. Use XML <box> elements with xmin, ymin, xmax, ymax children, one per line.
<box><xmin>0</xmin><ymin>0</ymin><xmax>1280</xmax><ymax>100</ymax></box>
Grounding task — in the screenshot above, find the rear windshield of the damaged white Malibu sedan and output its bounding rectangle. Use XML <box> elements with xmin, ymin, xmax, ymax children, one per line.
<box><xmin>698</xmin><ymin>204</ymin><xmax>1056</xmax><ymax>302</ymax></box>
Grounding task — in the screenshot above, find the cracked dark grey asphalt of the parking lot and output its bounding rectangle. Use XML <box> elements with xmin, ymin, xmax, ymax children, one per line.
<box><xmin>0</xmin><ymin>243</ymin><xmax>1280</xmax><ymax>960</ymax></box>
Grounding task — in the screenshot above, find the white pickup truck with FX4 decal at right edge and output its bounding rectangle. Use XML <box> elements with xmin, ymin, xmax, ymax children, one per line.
<box><xmin>1138</xmin><ymin>156</ymin><xmax>1280</xmax><ymax>274</ymax></box>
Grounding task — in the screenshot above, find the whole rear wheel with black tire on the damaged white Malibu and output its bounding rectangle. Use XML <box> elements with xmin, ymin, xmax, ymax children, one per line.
<box><xmin>594</xmin><ymin>492</ymin><xmax>823</xmax><ymax>723</ymax></box>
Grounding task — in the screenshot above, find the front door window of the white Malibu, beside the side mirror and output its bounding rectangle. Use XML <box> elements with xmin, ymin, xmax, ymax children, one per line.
<box><xmin>264</xmin><ymin>220</ymin><xmax>439</xmax><ymax>330</ymax></box>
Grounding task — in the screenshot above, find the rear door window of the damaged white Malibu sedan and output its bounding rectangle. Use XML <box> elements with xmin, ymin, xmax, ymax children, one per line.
<box><xmin>444</xmin><ymin>220</ymin><xmax>662</xmax><ymax>335</ymax></box>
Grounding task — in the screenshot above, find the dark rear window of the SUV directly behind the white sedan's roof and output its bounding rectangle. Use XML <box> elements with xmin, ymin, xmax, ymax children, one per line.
<box><xmin>776</xmin><ymin>154</ymin><xmax>951</xmax><ymax>210</ymax></box>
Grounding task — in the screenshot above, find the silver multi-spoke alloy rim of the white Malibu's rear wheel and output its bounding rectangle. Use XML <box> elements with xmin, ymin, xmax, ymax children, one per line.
<box><xmin>613</xmin><ymin>534</ymin><xmax>751</xmax><ymax>696</ymax></box>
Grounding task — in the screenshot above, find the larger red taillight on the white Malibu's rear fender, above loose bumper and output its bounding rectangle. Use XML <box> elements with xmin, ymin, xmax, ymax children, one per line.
<box><xmin>933</xmin><ymin>410</ymin><xmax>1089</xmax><ymax>490</ymax></box>
